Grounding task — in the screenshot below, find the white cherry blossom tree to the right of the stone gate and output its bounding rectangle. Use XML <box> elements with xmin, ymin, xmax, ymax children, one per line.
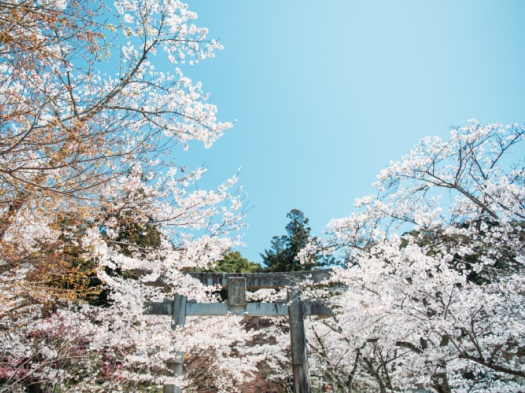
<box><xmin>302</xmin><ymin>121</ymin><xmax>525</xmax><ymax>392</ymax></box>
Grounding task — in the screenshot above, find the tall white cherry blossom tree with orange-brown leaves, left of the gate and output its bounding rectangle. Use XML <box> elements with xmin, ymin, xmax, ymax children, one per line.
<box><xmin>0</xmin><ymin>0</ymin><xmax>256</xmax><ymax>392</ymax></box>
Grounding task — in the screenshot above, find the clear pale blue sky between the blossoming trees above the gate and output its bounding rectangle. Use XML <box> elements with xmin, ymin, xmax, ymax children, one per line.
<box><xmin>179</xmin><ymin>0</ymin><xmax>525</xmax><ymax>262</ymax></box>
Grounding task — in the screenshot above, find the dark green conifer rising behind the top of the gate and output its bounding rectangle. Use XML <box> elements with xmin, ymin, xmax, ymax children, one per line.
<box><xmin>260</xmin><ymin>209</ymin><xmax>333</xmax><ymax>272</ymax></box>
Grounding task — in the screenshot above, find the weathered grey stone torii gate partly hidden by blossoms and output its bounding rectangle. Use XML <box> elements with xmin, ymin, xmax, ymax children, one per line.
<box><xmin>144</xmin><ymin>269</ymin><xmax>331</xmax><ymax>393</ymax></box>
